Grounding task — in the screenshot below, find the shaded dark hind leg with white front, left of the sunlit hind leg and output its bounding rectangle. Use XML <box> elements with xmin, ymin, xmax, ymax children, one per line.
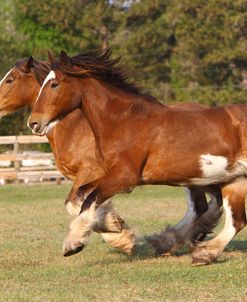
<box><xmin>146</xmin><ymin>187</ymin><xmax>208</xmax><ymax>255</ymax></box>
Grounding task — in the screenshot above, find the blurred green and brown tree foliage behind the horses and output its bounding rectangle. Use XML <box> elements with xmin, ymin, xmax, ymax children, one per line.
<box><xmin>0</xmin><ymin>0</ymin><xmax>247</xmax><ymax>133</ymax></box>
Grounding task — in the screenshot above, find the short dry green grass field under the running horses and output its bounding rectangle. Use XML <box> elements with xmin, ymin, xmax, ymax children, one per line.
<box><xmin>0</xmin><ymin>185</ymin><xmax>247</xmax><ymax>302</ymax></box>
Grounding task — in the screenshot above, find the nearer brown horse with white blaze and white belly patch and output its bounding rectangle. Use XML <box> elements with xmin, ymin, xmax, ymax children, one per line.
<box><xmin>29</xmin><ymin>52</ymin><xmax>247</xmax><ymax>264</ymax></box>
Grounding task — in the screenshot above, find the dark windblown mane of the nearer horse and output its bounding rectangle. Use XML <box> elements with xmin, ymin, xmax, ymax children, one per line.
<box><xmin>52</xmin><ymin>49</ymin><xmax>157</xmax><ymax>101</ymax></box>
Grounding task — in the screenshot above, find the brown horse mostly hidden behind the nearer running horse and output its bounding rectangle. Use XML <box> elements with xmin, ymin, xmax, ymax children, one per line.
<box><xmin>0</xmin><ymin>57</ymin><xmax>224</xmax><ymax>254</ymax></box>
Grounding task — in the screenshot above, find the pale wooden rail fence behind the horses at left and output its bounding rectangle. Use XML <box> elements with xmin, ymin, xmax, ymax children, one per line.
<box><xmin>0</xmin><ymin>135</ymin><xmax>64</xmax><ymax>185</ymax></box>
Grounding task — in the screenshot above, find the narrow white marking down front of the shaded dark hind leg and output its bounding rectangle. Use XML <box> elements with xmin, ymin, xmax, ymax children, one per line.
<box><xmin>174</xmin><ymin>188</ymin><xmax>196</xmax><ymax>234</ymax></box>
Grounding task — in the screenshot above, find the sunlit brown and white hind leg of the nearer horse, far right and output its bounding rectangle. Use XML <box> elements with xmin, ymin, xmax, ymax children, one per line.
<box><xmin>192</xmin><ymin>178</ymin><xmax>247</xmax><ymax>265</ymax></box>
